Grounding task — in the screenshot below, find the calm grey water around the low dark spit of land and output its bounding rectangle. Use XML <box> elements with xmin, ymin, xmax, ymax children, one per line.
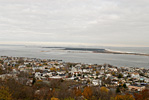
<box><xmin>0</xmin><ymin>45</ymin><xmax>149</xmax><ymax>68</ymax></box>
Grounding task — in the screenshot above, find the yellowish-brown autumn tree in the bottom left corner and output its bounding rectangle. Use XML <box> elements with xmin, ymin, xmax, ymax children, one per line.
<box><xmin>0</xmin><ymin>86</ymin><xmax>12</xmax><ymax>100</ymax></box>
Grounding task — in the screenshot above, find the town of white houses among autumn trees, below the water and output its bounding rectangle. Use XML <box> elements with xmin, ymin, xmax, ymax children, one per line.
<box><xmin>0</xmin><ymin>56</ymin><xmax>149</xmax><ymax>100</ymax></box>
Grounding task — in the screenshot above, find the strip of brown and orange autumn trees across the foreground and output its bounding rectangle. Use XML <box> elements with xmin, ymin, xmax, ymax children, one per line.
<box><xmin>0</xmin><ymin>79</ymin><xmax>149</xmax><ymax>100</ymax></box>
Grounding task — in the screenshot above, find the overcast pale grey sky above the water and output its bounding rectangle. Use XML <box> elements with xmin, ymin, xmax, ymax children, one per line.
<box><xmin>0</xmin><ymin>0</ymin><xmax>149</xmax><ymax>46</ymax></box>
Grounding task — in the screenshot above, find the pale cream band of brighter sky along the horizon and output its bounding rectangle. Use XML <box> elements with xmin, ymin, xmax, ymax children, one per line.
<box><xmin>0</xmin><ymin>41</ymin><xmax>149</xmax><ymax>47</ymax></box>
